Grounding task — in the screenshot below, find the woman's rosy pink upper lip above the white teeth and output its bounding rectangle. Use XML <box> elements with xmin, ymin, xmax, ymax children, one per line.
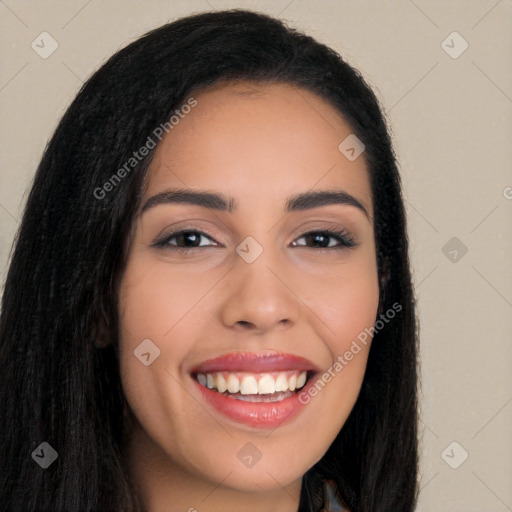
<box><xmin>191</xmin><ymin>352</ymin><xmax>319</xmax><ymax>374</ymax></box>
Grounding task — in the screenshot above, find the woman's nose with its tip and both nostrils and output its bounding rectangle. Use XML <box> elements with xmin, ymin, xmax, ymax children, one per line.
<box><xmin>220</xmin><ymin>251</ymin><xmax>300</xmax><ymax>334</ymax></box>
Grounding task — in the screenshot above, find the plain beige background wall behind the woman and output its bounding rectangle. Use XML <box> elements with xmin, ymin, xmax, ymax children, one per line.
<box><xmin>0</xmin><ymin>0</ymin><xmax>512</xmax><ymax>512</ymax></box>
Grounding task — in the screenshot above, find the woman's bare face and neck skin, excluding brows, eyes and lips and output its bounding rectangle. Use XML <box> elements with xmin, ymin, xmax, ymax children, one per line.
<box><xmin>119</xmin><ymin>83</ymin><xmax>379</xmax><ymax>512</ymax></box>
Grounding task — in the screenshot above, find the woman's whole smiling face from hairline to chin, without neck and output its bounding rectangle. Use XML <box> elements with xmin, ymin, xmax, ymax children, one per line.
<box><xmin>119</xmin><ymin>83</ymin><xmax>379</xmax><ymax>500</ymax></box>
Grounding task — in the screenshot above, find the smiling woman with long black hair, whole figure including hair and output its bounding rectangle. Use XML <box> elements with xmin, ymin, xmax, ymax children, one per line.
<box><xmin>0</xmin><ymin>10</ymin><xmax>417</xmax><ymax>512</ymax></box>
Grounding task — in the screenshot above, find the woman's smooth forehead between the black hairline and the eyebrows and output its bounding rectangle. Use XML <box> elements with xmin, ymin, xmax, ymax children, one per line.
<box><xmin>145</xmin><ymin>82</ymin><xmax>373</xmax><ymax>215</ymax></box>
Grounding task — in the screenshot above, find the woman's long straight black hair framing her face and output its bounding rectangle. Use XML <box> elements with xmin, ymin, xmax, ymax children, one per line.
<box><xmin>0</xmin><ymin>10</ymin><xmax>418</xmax><ymax>512</ymax></box>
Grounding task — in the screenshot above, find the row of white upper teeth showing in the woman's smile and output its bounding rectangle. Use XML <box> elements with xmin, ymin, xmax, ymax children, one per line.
<box><xmin>197</xmin><ymin>371</ymin><xmax>307</xmax><ymax>395</ymax></box>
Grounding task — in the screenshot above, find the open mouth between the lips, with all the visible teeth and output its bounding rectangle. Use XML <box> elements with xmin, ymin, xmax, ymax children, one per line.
<box><xmin>193</xmin><ymin>370</ymin><xmax>311</xmax><ymax>402</ymax></box>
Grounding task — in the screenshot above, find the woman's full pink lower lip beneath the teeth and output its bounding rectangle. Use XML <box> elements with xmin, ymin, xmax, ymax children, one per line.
<box><xmin>193</xmin><ymin>379</ymin><xmax>312</xmax><ymax>429</ymax></box>
